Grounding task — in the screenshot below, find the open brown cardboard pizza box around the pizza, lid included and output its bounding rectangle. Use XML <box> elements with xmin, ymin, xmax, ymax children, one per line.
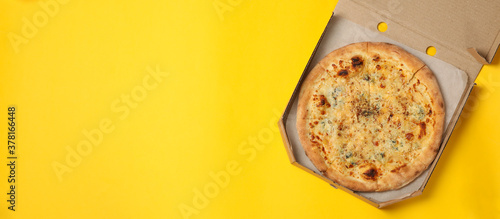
<box><xmin>278</xmin><ymin>0</ymin><xmax>500</xmax><ymax>208</ymax></box>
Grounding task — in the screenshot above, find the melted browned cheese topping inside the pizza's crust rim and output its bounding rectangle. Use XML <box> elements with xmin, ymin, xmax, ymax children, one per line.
<box><xmin>307</xmin><ymin>51</ymin><xmax>435</xmax><ymax>181</ymax></box>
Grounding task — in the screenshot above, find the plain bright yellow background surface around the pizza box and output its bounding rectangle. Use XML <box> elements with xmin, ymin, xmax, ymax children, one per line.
<box><xmin>0</xmin><ymin>0</ymin><xmax>500</xmax><ymax>218</ymax></box>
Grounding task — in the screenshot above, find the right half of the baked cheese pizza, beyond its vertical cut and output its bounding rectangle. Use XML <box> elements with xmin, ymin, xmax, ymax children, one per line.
<box><xmin>360</xmin><ymin>43</ymin><xmax>444</xmax><ymax>190</ymax></box>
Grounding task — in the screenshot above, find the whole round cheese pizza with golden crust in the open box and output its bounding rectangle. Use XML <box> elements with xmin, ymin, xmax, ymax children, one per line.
<box><xmin>296</xmin><ymin>42</ymin><xmax>445</xmax><ymax>191</ymax></box>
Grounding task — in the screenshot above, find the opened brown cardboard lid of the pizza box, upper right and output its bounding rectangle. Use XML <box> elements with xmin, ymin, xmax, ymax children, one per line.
<box><xmin>335</xmin><ymin>0</ymin><xmax>500</xmax><ymax>81</ymax></box>
